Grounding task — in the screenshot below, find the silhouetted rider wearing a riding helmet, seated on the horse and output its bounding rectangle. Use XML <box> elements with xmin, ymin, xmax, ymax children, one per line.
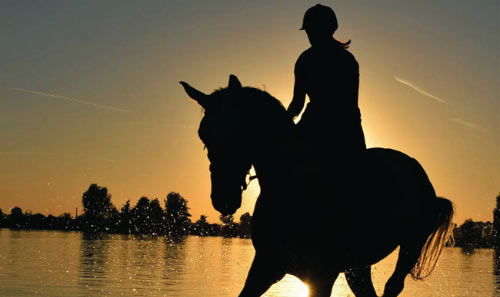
<box><xmin>288</xmin><ymin>4</ymin><xmax>366</xmax><ymax>160</ymax></box>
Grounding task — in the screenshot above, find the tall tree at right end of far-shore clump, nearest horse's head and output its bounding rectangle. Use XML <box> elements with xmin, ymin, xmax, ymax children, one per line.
<box><xmin>165</xmin><ymin>192</ymin><xmax>191</xmax><ymax>237</ymax></box>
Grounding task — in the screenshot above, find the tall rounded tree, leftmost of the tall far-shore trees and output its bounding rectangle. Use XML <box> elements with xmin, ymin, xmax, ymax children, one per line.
<box><xmin>82</xmin><ymin>184</ymin><xmax>116</xmax><ymax>232</ymax></box>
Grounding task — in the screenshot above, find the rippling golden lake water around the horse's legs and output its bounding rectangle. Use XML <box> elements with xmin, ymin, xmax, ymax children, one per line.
<box><xmin>0</xmin><ymin>229</ymin><xmax>500</xmax><ymax>297</ymax></box>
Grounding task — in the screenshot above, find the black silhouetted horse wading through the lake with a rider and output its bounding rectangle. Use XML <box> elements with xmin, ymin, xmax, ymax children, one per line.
<box><xmin>180</xmin><ymin>75</ymin><xmax>454</xmax><ymax>297</ymax></box>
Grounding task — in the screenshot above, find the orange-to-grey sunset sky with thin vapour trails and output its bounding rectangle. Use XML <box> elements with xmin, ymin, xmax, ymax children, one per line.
<box><xmin>0</xmin><ymin>0</ymin><xmax>500</xmax><ymax>223</ymax></box>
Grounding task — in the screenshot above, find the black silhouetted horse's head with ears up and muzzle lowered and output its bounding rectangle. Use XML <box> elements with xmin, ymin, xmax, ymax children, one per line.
<box><xmin>181</xmin><ymin>75</ymin><xmax>252</xmax><ymax>215</ymax></box>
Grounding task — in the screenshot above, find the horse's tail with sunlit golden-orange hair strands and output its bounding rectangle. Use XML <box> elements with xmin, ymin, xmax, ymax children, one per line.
<box><xmin>410</xmin><ymin>197</ymin><xmax>455</xmax><ymax>280</ymax></box>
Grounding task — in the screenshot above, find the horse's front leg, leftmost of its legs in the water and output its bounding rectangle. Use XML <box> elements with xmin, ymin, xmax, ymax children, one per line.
<box><xmin>239</xmin><ymin>253</ymin><xmax>285</xmax><ymax>297</ymax></box>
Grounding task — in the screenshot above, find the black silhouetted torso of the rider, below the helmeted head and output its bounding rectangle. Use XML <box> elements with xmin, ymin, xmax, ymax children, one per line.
<box><xmin>295</xmin><ymin>40</ymin><xmax>366</xmax><ymax>153</ymax></box>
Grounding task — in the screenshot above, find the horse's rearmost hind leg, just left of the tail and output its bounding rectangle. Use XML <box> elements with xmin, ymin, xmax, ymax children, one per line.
<box><xmin>382</xmin><ymin>243</ymin><xmax>423</xmax><ymax>297</ymax></box>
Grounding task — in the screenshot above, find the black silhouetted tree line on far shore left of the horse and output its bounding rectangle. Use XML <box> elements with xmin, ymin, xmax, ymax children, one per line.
<box><xmin>0</xmin><ymin>184</ymin><xmax>252</xmax><ymax>238</ymax></box>
